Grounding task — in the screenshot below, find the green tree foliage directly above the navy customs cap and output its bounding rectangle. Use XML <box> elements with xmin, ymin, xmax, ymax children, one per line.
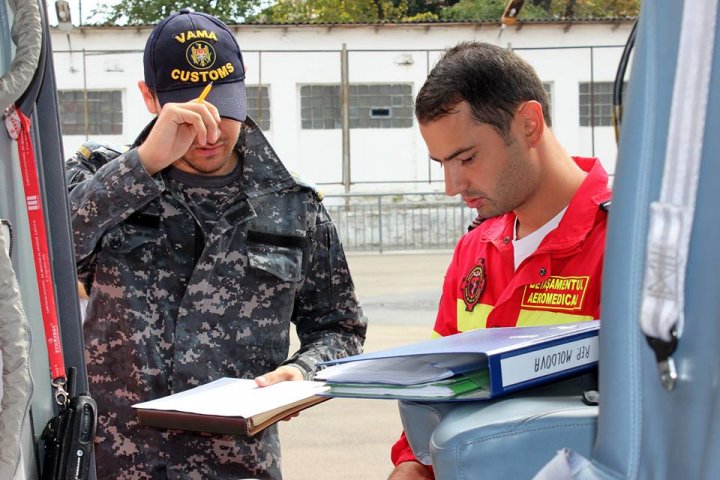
<box><xmin>92</xmin><ymin>0</ymin><xmax>265</xmax><ymax>25</ymax></box>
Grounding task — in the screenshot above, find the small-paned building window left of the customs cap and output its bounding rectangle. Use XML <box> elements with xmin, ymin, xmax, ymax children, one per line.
<box><xmin>58</xmin><ymin>90</ymin><xmax>123</xmax><ymax>135</ymax></box>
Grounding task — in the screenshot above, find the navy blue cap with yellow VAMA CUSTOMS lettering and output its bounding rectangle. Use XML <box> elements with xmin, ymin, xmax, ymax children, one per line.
<box><xmin>143</xmin><ymin>8</ymin><xmax>247</xmax><ymax>122</ymax></box>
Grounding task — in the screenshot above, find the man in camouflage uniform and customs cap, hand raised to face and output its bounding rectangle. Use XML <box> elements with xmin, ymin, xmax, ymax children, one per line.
<box><xmin>67</xmin><ymin>10</ymin><xmax>366</xmax><ymax>479</ymax></box>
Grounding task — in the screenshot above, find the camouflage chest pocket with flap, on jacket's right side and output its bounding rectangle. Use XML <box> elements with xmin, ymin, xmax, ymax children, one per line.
<box><xmin>247</xmin><ymin>232</ymin><xmax>303</xmax><ymax>283</ymax></box>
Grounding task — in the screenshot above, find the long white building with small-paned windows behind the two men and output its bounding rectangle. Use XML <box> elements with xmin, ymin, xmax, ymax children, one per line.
<box><xmin>52</xmin><ymin>20</ymin><xmax>632</xmax><ymax>193</ymax></box>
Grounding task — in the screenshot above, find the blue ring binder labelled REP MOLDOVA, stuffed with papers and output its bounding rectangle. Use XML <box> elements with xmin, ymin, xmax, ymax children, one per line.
<box><xmin>316</xmin><ymin>321</ymin><xmax>600</xmax><ymax>401</ymax></box>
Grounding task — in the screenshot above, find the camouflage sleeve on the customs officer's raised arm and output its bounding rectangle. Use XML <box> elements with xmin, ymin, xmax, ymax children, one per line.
<box><xmin>65</xmin><ymin>149</ymin><xmax>163</xmax><ymax>278</ymax></box>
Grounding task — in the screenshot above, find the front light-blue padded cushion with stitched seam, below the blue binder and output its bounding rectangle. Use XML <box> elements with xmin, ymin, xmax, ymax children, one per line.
<box><xmin>429</xmin><ymin>396</ymin><xmax>598</xmax><ymax>479</ymax></box>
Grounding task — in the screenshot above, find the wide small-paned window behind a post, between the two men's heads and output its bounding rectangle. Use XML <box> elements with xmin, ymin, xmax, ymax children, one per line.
<box><xmin>300</xmin><ymin>84</ymin><xmax>414</xmax><ymax>130</ymax></box>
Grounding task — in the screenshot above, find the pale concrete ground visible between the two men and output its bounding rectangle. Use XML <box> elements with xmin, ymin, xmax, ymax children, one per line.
<box><xmin>280</xmin><ymin>251</ymin><xmax>452</xmax><ymax>480</ymax></box>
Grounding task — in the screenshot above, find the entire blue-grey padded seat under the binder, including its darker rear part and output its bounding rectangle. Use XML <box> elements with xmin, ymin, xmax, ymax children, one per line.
<box><xmin>400</xmin><ymin>373</ymin><xmax>598</xmax><ymax>479</ymax></box>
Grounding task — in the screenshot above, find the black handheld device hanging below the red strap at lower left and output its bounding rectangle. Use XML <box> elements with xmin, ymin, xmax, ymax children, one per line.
<box><xmin>41</xmin><ymin>368</ymin><xmax>97</xmax><ymax>480</ymax></box>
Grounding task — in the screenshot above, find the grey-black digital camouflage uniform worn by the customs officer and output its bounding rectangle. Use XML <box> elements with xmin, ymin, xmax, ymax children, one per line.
<box><xmin>67</xmin><ymin>120</ymin><xmax>366</xmax><ymax>479</ymax></box>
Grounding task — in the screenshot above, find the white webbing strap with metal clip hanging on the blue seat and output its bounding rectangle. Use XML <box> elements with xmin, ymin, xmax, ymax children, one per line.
<box><xmin>640</xmin><ymin>0</ymin><xmax>718</xmax><ymax>388</ymax></box>
